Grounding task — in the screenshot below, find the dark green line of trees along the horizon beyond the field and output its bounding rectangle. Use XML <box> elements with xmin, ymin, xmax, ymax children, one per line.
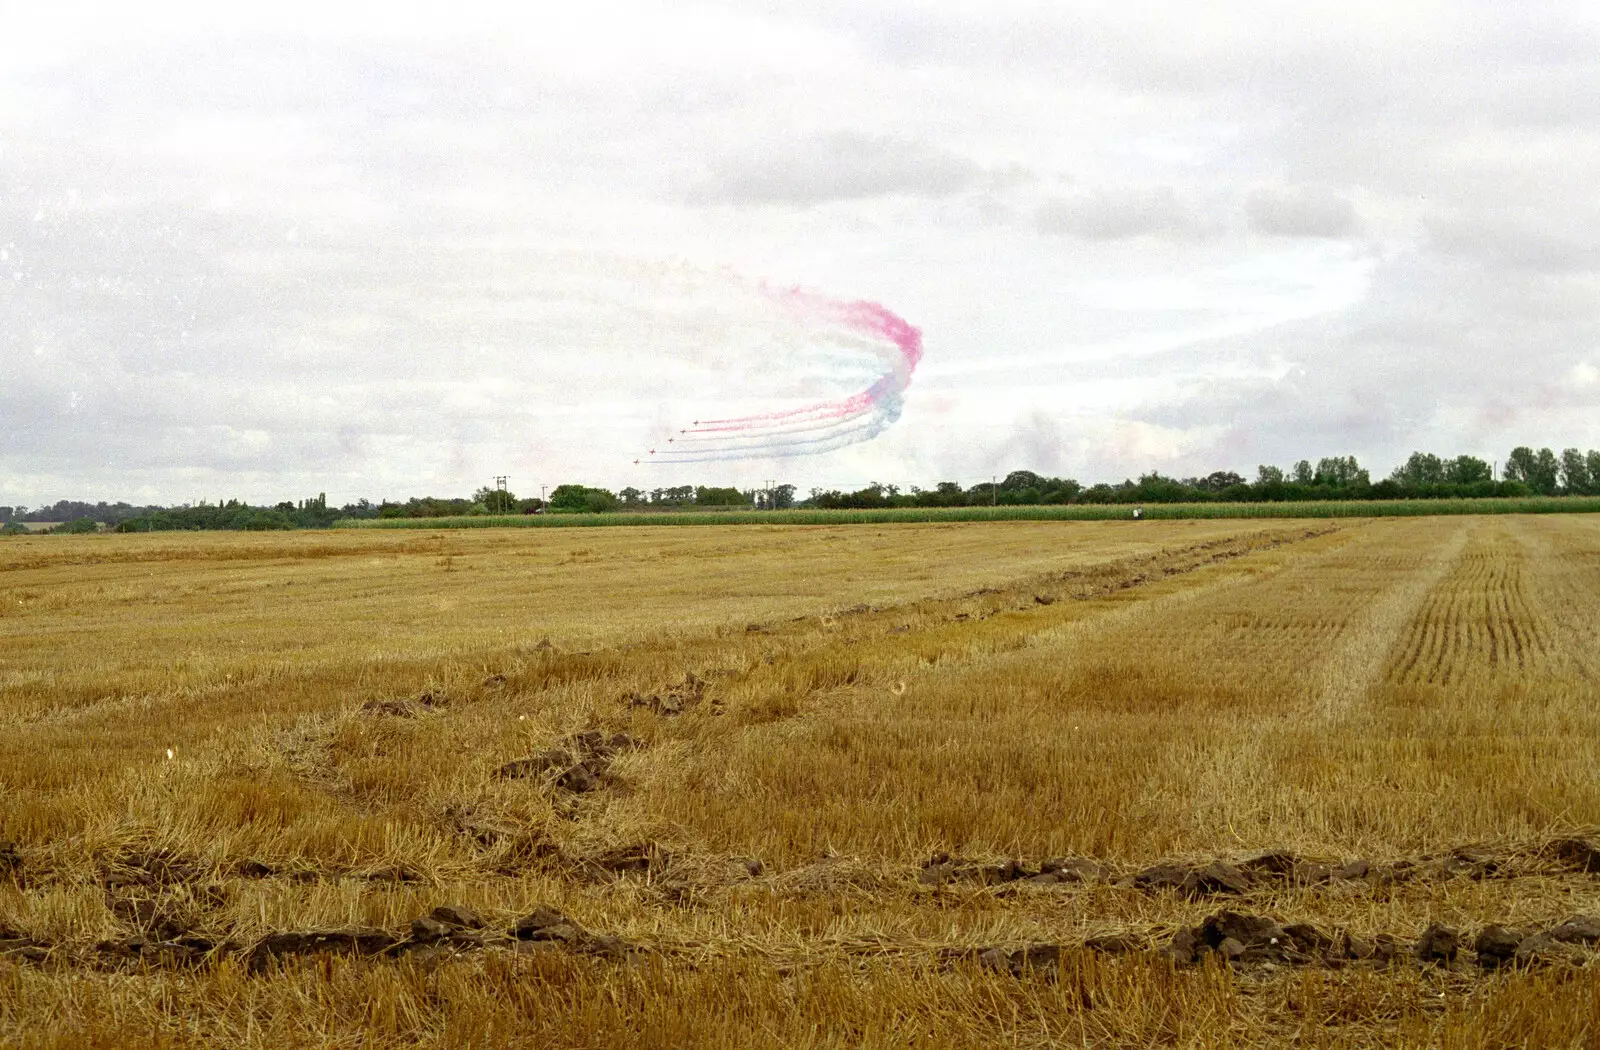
<box><xmin>0</xmin><ymin>445</ymin><xmax>1600</xmax><ymax>535</ymax></box>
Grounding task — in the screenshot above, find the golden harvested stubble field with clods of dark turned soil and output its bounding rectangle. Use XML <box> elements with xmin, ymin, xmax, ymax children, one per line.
<box><xmin>0</xmin><ymin>515</ymin><xmax>1600</xmax><ymax>1048</ymax></box>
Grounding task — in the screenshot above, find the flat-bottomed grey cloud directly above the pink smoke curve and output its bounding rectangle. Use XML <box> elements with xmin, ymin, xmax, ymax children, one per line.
<box><xmin>688</xmin><ymin>131</ymin><xmax>986</xmax><ymax>205</ymax></box>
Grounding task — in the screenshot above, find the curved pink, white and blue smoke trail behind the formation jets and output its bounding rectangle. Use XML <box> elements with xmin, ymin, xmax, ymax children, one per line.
<box><xmin>650</xmin><ymin>288</ymin><xmax>922</xmax><ymax>463</ymax></box>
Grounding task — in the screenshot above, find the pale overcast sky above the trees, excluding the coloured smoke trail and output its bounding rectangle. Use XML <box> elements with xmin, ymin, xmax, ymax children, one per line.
<box><xmin>0</xmin><ymin>0</ymin><xmax>1600</xmax><ymax>506</ymax></box>
